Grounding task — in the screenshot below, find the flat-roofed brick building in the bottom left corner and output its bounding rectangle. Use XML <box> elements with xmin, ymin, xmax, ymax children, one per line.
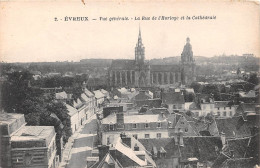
<box><xmin>0</xmin><ymin>113</ymin><xmax>59</xmax><ymax>168</ymax></box>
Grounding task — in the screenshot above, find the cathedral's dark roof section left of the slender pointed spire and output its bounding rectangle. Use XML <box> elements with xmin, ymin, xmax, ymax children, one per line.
<box><xmin>111</xmin><ymin>59</ymin><xmax>135</xmax><ymax>70</ymax></box>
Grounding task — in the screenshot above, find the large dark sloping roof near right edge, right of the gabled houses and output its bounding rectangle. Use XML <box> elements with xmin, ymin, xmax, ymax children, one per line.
<box><xmin>215</xmin><ymin>116</ymin><xmax>251</xmax><ymax>138</ymax></box>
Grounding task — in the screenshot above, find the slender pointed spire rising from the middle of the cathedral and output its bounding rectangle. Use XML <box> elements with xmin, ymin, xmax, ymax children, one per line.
<box><xmin>135</xmin><ymin>26</ymin><xmax>145</xmax><ymax>66</ymax></box>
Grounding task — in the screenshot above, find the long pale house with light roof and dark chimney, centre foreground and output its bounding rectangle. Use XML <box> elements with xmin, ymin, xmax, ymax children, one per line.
<box><xmin>101</xmin><ymin>112</ymin><xmax>169</xmax><ymax>145</ymax></box>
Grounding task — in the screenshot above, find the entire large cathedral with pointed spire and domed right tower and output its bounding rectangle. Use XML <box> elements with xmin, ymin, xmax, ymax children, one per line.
<box><xmin>109</xmin><ymin>29</ymin><xmax>196</xmax><ymax>87</ymax></box>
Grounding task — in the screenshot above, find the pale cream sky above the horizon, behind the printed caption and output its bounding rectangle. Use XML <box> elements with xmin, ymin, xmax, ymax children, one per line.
<box><xmin>0</xmin><ymin>0</ymin><xmax>260</xmax><ymax>62</ymax></box>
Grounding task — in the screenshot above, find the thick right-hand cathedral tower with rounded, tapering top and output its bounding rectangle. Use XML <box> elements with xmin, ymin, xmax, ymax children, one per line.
<box><xmin>181</xmin><ymin>37</ymin><xmax>196</xmax><ymax>85</ymax></box>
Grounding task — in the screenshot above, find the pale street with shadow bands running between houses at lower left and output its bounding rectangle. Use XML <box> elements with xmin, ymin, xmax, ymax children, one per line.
<box><xmin>66</xmin><ymin>115</ymin><xmax>97</xmax><ymax>168</ymax></box>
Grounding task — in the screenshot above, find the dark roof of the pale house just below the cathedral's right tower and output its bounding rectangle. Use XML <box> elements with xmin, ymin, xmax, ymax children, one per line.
<box><xmin>162</xmin><ymin>92</ymin><xmax>185</xmax><ymax>104</ymax></box>
